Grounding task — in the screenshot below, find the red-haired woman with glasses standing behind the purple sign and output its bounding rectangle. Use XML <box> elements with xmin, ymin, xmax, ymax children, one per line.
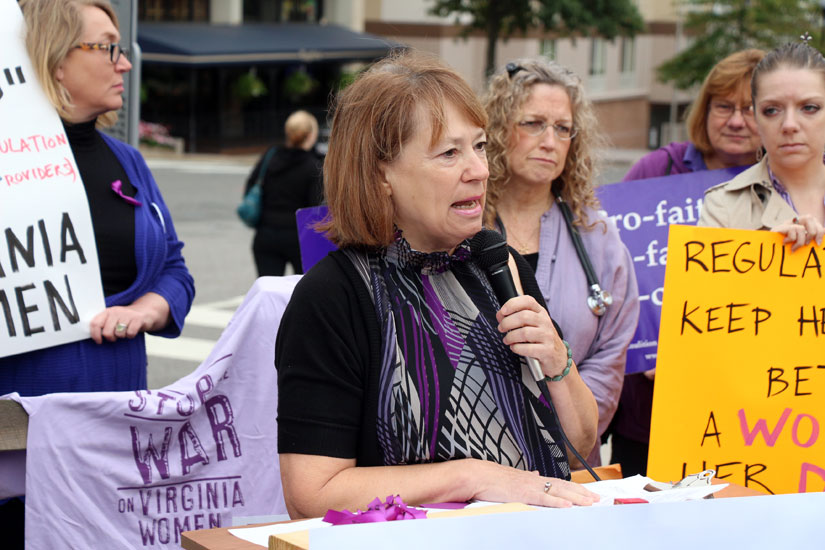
<box><xmin>610</xmin><ymin>49</ymin><xmax>765</xmax><ymax>476</ymax></box>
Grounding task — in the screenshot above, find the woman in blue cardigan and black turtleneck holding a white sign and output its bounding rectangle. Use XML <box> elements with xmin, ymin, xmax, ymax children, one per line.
<box><xmin>0</xmin><ymin>0</ymin><xmax>195</xmax><ymax>544</ymax></box>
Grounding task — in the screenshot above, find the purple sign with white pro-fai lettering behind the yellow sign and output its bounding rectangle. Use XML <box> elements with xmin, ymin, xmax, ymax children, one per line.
<box><xmin>596</xmin><ymin>168</ymin><xmax>744</xmax><ymax>374</ymax></box>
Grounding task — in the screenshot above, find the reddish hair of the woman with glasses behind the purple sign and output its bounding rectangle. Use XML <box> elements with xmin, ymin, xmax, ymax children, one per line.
<box><xmin>686</xmin><ymin>49</ymin><xmax>765</xmax><ymax>154</ymax></box>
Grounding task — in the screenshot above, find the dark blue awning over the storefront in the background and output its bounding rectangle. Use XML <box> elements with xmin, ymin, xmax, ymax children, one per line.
<box><xmin>138</xmin><ymin>23</ymin><xmax>398</xmax><ymax>66</ymax></box>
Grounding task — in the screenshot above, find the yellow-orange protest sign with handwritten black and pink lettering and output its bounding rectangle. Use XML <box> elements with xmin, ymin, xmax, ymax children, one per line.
<box><xmin>648</xmin><ymin>226</ymin><xmax>825</xmax><ymax>493</ymax></box>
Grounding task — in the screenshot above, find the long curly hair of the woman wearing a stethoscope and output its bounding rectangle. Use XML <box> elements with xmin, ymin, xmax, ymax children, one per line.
<box><xmin>483</xmin><ymin>58</ymin><xmax>605</xmax><ymax>231</ymax></box>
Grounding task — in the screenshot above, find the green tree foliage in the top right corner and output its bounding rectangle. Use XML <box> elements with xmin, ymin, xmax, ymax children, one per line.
<box><xmin>658</xmin><ymin>0</ymin><xmax>823</xmax><ymax>90</ymax></box>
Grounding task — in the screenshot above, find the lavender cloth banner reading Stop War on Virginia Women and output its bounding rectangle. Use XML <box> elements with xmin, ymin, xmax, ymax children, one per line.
<box><xmin>12</xmin><ymin>276</ymin><xmax>300</xmax><ymax>550</ymax></box>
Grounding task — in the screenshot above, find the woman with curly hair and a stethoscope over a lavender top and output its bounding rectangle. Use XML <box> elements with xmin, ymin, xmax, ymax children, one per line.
<box><xmin>484</xmin><ymin>58</ymin><xmax>639</xmax><ymax>466</ymax></box>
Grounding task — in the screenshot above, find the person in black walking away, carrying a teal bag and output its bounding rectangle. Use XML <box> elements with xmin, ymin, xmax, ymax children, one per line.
<box><xmin>244</xmin><ymin>111</ymin><xmax>323</xmax><ymax>277</ymax></box>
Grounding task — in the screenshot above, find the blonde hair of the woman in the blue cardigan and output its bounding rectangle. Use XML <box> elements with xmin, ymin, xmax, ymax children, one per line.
<box><xmin>20</xmin><ymin>0</ymin><xmax>120</xmax><ymax>126</ymax></box>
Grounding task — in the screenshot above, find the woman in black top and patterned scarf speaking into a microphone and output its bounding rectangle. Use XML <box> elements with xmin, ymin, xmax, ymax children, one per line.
<box><xmin>276</xmin><ymin>49</ymin><xmax>598</xmax><ymax>517</ymax></box>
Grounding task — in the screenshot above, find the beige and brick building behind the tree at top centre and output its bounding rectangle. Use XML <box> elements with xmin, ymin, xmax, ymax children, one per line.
<box><xmin>358</xmin><ymin>0</ymin><xmax>690</xmax><ymax>149</ymax></box>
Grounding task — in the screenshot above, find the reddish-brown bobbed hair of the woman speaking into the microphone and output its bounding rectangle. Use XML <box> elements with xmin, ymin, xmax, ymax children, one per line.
<box><xmin>319</xmin><ymin>51</ymin><xmax>487</xmax><ymax>248</ymax></box>
